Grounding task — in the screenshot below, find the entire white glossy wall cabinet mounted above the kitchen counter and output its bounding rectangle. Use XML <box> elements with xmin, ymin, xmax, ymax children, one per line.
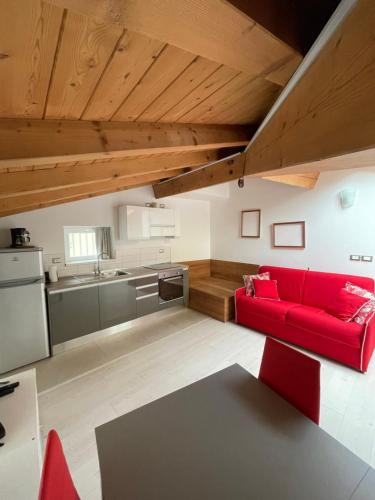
<box><xmin>119</xmin><ymin>205</ymin><xmax>180</xmax><ymax>240</ymax></box>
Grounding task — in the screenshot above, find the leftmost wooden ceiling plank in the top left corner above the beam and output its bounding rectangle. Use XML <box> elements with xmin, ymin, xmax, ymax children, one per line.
<box><xmin>0</xmin><ymin>0</ymin><xmax>63</xmax><ymax>118</ymax></box>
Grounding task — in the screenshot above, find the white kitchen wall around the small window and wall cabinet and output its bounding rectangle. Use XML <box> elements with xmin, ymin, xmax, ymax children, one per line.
<box><xmin>0</xmin><ymin>187</ymin><xmax>210</xmax><ymax>270</ymax></box>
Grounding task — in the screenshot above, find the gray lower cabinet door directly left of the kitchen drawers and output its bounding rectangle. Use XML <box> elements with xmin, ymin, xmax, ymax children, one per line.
<box><xmin>99</xmin><ymin>281</ymin><xmax>137</xmax><ymax>329</ymax></box>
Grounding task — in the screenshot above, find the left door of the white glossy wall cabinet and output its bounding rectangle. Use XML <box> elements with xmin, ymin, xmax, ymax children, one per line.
<box><xmin>119</xmin><ymin>205</ymin><xmax>150</xmax><ymax>240</ymax></box>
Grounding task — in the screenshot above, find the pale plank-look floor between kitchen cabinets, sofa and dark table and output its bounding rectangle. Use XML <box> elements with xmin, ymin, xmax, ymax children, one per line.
<box><xmin>36</xmin><ymin>308</ymin><xmax>375</xmax><ymax>500</ymax></box>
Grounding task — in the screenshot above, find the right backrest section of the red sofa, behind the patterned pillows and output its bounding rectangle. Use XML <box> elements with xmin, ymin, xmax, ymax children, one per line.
<box><xmin>302</xmin><ymin>271</ymin><xmax>374</xmax><ymax>309</ymax></box>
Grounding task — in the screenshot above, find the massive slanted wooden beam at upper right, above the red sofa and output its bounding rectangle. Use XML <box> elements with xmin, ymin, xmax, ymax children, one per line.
<box><xmin>246</xmin><ymin>0</ymin><xmax>375</xmax><ymax>176</ymax></box>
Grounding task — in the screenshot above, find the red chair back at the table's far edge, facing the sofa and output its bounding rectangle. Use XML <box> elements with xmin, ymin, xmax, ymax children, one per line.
<box><xmin>259</xmin><ymin>337</ymin><xmax>320</xmax><ymax>424</ymax></box>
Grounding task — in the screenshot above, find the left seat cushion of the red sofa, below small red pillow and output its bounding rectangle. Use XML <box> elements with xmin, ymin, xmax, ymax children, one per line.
<box><xmin>236</xmin><ymin>295</ymin><xmax>299</xmax><ymax>322</ymax></box>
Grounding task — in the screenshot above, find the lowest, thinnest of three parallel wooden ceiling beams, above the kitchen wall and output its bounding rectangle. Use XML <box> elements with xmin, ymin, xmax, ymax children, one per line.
<box><xmin>0</xmin><ymin>168</ymin><xmax>195</xmax><ymax>217</ymax></box>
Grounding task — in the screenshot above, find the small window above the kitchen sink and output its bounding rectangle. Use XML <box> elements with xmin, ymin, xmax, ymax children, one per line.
<box><xmin>64</xmin><ymin>226</ymin><xmax>114</xmax><ymax>264</ymax></box>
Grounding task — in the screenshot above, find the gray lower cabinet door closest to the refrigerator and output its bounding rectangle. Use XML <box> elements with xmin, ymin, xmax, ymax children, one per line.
<box><xmin>48</xmin><ymin>286</ymin><xmax>100</xmax><ymax>345</ymax></box>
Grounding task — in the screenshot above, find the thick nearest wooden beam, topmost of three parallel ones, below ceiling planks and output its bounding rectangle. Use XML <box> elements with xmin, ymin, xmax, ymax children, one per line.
<box><xmin>0</xmin><ymin>119</ymin><xmax>254</xmax><ymax>169</ymax></box>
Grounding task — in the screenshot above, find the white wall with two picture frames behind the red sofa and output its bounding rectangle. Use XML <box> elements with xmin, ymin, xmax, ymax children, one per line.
<box><xmin>211</xmin><ymin>168</ymin><xmax>375</xmax><ymax>276</ymax></box>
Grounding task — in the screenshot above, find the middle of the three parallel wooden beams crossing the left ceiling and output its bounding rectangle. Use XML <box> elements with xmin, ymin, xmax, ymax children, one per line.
<box><xmin>0</xmin><ymin>151</ymin><xmax>218</xmax><ymax>198</ymax></box>
